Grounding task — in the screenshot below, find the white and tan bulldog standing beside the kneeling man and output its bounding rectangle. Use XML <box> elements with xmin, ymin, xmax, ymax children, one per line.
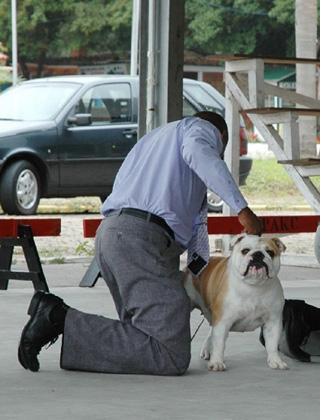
<box><xmin>184</xmin><ymin>234</ymin><xmax>288</xmax><ymax>371</ymax></box>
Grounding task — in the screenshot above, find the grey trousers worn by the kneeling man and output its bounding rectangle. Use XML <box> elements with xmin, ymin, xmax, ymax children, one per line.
<box><xmin>61</xmin><ymin>214</ymin><xmax>190</xmax><ymax>375</ymax></box>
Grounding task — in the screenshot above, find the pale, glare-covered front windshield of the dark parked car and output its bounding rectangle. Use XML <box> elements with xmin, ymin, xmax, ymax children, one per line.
<box><xmin>0</xmin><ymin>83</ymin><xmax>81</xmax><ymax>121</ymax></box>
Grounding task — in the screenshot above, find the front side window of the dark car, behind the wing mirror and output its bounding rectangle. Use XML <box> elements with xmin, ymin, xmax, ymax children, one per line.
<box><xmin>75</xmin><ymin>83</ymin><xmax>131</xmax><ymax>125</ymax></box>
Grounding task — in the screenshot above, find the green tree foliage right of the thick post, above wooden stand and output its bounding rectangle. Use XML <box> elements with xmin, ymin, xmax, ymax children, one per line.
<box><xmin>186</xmin><ymin>0</ymin><xmax>294</xmax><ymax>56</ymax></box>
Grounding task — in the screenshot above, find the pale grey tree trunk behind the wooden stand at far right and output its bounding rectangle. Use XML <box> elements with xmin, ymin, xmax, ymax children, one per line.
<box><xmin>295</xmin><ymin>0</ymin><xmax>317</xmax><ymax>157</ymax></box>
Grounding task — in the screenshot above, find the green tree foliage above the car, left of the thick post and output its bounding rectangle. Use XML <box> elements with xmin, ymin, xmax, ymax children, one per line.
<box><xmin>0</xmin><ymin>0</ymin><xmax>131</xmax><ymax>78</ymax></box>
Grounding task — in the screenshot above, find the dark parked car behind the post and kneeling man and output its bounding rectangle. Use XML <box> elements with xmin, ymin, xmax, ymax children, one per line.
<box><xmin>0</xmin><ymin>75</ymin><xmax>251</xmax><ymax>215</ymax></box>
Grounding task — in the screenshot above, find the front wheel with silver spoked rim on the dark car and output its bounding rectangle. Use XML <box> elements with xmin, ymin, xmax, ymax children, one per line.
<box><xmin>0</xmin><ymin>160</ymin><xmax>40</xmax><ymax>215</ymax></box>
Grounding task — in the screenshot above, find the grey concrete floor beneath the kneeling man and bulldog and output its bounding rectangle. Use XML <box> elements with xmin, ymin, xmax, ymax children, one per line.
<box><xmin>0</xmin><ymin>263</ymin><xmax>320</xmax><ymax>420</ymax></box>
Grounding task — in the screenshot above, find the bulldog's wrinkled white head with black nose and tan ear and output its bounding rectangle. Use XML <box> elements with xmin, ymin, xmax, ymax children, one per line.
<box><xmin>231</xmin><ymin>234</ymin><xmax>286</xmax><ymax>285</ymax></box>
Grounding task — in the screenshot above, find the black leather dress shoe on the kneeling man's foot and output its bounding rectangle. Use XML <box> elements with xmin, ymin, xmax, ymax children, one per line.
<box><xmin>18</xmin><ymin>292</ymin><xmax>69</xmax><ymax>372</ymax></box>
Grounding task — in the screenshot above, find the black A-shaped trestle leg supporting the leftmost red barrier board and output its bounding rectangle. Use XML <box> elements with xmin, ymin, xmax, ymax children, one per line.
<box><xmin>0</xmin><ymin>225</ymin><xmax>49</xmax><ymax>292</ymax></box>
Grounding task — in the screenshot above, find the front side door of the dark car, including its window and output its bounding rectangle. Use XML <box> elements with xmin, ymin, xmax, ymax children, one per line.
<box><xmin>59</xmin><ymin>82</ymin><xmax>137</xmax><ymax>195</ymax></box>
